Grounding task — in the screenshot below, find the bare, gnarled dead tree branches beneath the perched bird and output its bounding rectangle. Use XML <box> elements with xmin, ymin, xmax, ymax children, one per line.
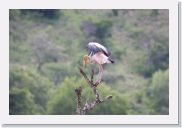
<box><xmin>75</xmin><ymin>67</ymin><xmax>112</xmax><ymax>115</ymax></box>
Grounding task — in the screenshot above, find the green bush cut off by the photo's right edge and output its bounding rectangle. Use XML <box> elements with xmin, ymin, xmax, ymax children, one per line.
<box><xmin>150</xmin><ymin>70</ymin><xmax>169</xmax><ymax>114</ymax></box>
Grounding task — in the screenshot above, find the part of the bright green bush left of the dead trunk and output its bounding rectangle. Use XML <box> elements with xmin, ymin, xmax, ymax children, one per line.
<box><xmin>48</xmin><ymin>77</ymin><xmax>79</xmax><ymax>115</ymax></box>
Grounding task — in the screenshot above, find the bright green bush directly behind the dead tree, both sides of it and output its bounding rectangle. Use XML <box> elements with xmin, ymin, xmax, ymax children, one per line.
<box><xmin>48</xmin><ymin>77</ymin><xmax>127</xmax><ymax>115</ymax></box>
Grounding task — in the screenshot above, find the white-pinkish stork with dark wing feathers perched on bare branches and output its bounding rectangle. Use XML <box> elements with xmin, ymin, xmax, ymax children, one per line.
<box><xmin>83</xmin><ymin>42</ymin><xmax>114</xmax><ymax>81</ymax></box>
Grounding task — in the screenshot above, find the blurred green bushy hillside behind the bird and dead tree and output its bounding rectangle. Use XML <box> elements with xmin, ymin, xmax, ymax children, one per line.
<box><xmin>9</xmin><ymin>9</ymin><xmax>169</xmax><ymax>115</ymax></box>
